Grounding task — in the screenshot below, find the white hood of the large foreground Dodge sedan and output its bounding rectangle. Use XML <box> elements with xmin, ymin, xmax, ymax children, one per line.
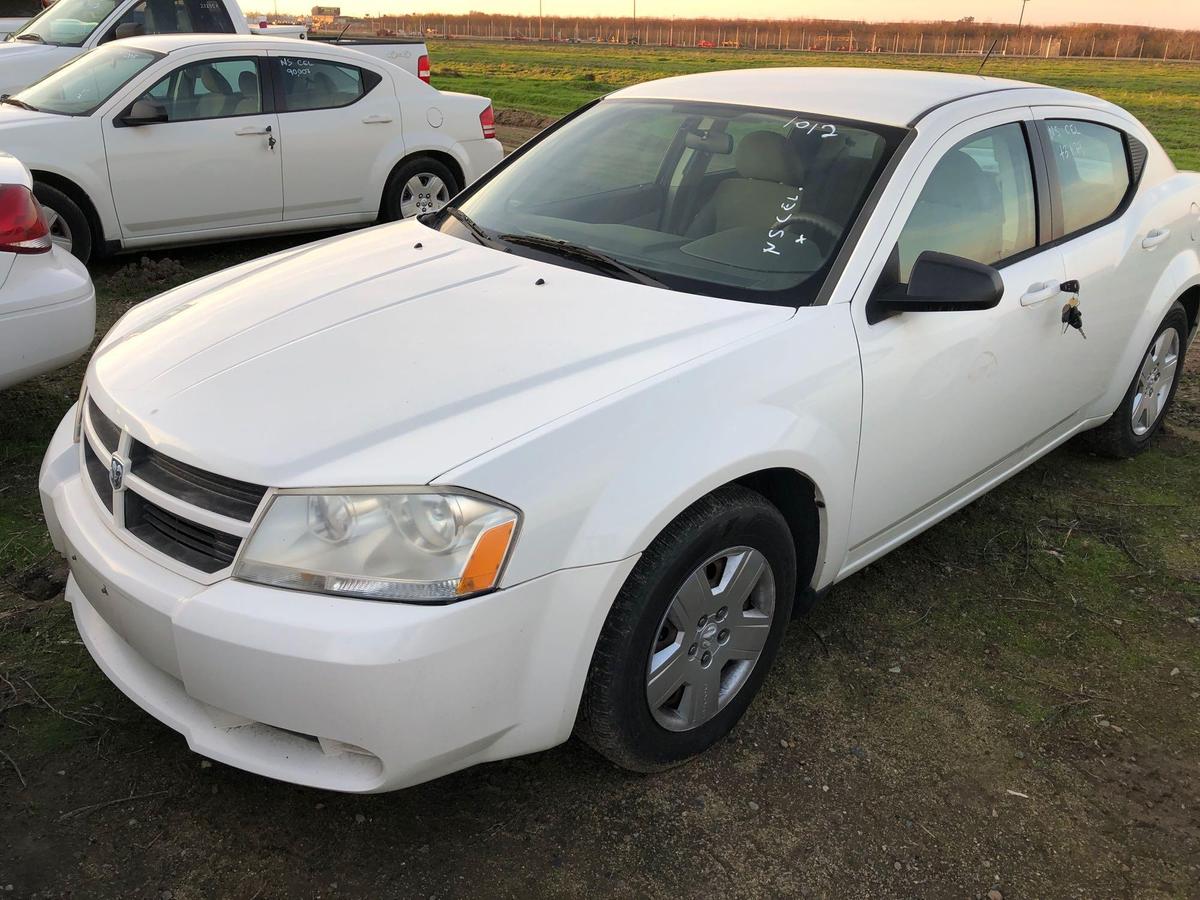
<box><xmin>89</xmin><ymin>222</ymin><xmax>794</xmax><ymax>487</ymax></box>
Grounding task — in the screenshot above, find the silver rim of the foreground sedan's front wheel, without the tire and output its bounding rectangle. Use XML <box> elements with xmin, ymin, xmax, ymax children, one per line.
<box><xmin>646</xmin><ymin>547</ymin><xmax>775</xmax><ymax>731</ymax></box>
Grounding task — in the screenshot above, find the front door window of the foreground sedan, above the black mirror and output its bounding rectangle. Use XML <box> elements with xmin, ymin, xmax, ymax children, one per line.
<box><xmin>899</xmin><ymin>122</ymin><xmax>1037</xmax><ymax>283</ymax></box>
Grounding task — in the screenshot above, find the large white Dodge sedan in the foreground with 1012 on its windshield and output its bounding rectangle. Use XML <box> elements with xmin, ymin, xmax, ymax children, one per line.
<box><xmin>41</xmin><ymin>68</ymin><xmax>1200</xmax><ymax>791</ymax></box>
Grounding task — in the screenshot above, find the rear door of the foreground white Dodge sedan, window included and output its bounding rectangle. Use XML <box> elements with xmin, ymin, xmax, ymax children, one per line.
<box><xmin>1034</xmin><ymin>107</ymin><xmax>1166</xmax><ymax>415</ymax></box>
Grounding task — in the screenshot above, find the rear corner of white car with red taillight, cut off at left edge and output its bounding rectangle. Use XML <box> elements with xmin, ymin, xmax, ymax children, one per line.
<box><xmin>0</xmin><ymin>154</ymin><xmax>96</xmax><ymax>390</ymax></box>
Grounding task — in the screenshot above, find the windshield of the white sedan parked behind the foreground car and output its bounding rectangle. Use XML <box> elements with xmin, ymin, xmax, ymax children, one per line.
<box><xmin>13</xmin><ymin>43</ymin><xmax>162</xmax><ymax>115</ymax></box>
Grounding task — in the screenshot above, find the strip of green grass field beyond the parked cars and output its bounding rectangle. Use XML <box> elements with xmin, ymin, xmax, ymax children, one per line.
<box><xmin>430</xmin><ymin>41</ymin><xmax>1200</xmax><ymax>169</ymax></box>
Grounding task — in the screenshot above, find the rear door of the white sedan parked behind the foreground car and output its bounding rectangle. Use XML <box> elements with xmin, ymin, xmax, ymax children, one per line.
<box><xmin>270</xmin><ymin>53</ymin><xmax>400</xmax><ymax>220</ymax></box>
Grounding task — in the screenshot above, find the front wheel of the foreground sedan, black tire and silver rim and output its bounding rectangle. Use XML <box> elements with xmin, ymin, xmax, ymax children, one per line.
<box><xmin>576</xmin><ymin>486</ymin><xmax>796</xmax><ymax>772</ymax></box>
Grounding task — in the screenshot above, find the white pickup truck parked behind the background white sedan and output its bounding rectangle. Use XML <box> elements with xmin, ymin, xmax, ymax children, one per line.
<box><xmin>0</xmin><ymin>0</ymin><xmax>430</xmax><ymax>94</ymax></box>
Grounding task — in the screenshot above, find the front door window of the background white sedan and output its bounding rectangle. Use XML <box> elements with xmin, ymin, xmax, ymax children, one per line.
<box><xmin>140</xmin><ymin>59</ymin><xmax>263</xmax><ymax>122</ymax></box>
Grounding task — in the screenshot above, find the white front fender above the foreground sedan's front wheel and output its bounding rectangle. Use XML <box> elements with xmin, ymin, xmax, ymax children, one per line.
<box><xmin>434</xmin><ymin>304</ymin><xmax>862</xmax><ymax>588</ymax></box>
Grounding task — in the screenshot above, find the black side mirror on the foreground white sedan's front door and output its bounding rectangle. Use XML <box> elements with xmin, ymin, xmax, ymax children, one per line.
<box><xmin>868</xmin><ymin>250</ymin><xmax>1004</xmax><ymax>324</ymax></box>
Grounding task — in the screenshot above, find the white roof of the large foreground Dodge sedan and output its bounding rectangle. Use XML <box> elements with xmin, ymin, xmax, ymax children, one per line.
<box><xmin>611</xmin><ymin>66</ymin><xmax>1081</xmax><ymax>126</ymax></box>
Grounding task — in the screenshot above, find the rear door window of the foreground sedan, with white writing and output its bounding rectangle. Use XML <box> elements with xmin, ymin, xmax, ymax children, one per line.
<box><xmin>1046</xmin><ymin>119</ymin><xmax>1130</xmax><ymax>234</ymax></box>
